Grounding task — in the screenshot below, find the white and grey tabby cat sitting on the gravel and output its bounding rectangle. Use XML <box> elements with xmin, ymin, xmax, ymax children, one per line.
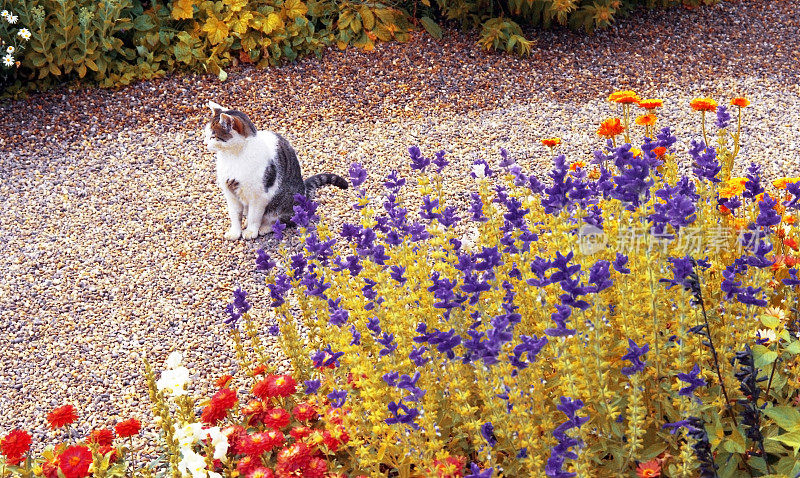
<box><xmin>204</xmin><ymin>101</ymin><xmax>348</xmax><ymax>241</ymax></box>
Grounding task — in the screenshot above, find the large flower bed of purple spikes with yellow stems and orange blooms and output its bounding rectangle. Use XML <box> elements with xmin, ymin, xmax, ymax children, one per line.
<box><xmin>248</xmin><ymin>92</ymin><xmax>800</xmax><ymax>477</ymax></box>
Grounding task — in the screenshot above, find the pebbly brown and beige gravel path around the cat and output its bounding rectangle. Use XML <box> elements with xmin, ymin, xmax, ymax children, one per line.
<box><xmin>0</xmin><ymin>0</ymin><xmax>800</xmax><ymax>456</ymax></box>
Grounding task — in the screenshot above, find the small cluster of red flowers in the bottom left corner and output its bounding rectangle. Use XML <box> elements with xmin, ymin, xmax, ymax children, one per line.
<box><xmin>0</xmin><ymin>405</ymin><xmax>142</xmax><ymax>478</ymax></box>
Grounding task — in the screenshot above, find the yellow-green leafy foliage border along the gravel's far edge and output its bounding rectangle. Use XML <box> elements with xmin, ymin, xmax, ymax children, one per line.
<box><xmin>0</xmin><ymin>0</ymin><xmax>715</xmax><ymax>94</ymax></box>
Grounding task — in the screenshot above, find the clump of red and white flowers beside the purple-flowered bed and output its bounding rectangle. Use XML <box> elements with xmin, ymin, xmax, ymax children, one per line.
<box><xmin>141</xmin><ymin>348</ymin><xmax>360</xmax><ymax>478</ymax></box>
